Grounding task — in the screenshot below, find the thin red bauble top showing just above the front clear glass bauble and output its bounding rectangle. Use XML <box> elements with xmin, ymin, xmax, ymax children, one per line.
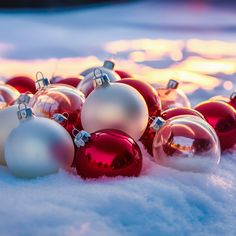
<box><xmin>161</xmin><ymin>107</ymin><xmax>205</xmax><ymax>120</ymax></box>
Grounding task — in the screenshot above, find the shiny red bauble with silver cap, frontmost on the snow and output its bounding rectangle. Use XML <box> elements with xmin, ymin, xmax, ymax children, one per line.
<box><xmin>75</xmin><ymin>130</ymin><xmax>142</xmax><ymax>178</ymax></box>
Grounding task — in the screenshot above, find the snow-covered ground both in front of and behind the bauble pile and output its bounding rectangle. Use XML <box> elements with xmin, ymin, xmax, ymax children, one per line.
<box><xmin>0</xmin><ymin>1</ymin><xmax>236</xmax><ymax>236</ymax></box>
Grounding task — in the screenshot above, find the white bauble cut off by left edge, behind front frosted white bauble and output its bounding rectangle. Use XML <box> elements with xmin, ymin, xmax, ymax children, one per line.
<box><xmin>0</xmin><ymin>105</ymin><xmax>19</xmax><ymax>165</ymax></box>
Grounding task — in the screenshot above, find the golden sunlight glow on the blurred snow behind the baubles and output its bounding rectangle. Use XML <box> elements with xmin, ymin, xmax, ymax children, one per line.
<box><xmin>0</xmin><ymin>39</ymin><xmax>236</xmax><ymax>97</ymax></box>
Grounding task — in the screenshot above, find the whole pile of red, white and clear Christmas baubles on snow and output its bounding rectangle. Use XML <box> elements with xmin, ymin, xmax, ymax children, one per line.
<box><xmin>0</xmin><ymin>60</ymin><xmax>236</xmax><ymax>178</ymax></box>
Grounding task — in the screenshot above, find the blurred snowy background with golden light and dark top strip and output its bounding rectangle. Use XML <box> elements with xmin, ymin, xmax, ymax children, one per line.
<box><xmin>0</xmin><ymin>0</ymin><xmax>236</xmax><ymax>105</ymax></box>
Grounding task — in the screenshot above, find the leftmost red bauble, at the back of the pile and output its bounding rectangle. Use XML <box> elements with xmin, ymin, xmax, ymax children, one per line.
<box><xmin>6</xmin><ymin>76</ymin><xmax>36</xmax><ymax>94</ymax></box>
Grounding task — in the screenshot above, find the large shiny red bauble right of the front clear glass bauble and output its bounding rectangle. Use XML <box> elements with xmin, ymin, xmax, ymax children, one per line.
<box><xmin>195</xmin><ymin>101</ymin><xmax>236</xmax><ymax>150</ymax></box>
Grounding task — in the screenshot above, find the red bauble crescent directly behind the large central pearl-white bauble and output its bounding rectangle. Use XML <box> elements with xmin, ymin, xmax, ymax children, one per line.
<box><xmin>117</xmin><ymin>79</ymin><xmax>161</xmax><ymax>116</ymax></box>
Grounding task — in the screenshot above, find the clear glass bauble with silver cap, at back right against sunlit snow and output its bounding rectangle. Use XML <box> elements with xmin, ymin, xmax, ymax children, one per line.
<box><xmin>157</xmin><ymin>79</ymin><xmax>191</xmax><ymax>110</ymax></box>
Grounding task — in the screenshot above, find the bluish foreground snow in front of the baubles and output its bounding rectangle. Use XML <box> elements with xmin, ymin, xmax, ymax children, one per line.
<box><xmin>0</xmin><ymin>148</ymin><xmax>236</xmax><ymax>235</ymax></box>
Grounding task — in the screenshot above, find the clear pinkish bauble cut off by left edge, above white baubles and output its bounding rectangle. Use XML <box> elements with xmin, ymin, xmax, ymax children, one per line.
<box><xmin>0</xmin><ymin>84</ymin><xmax>20</xmax><ymax>108</ymax></box>
